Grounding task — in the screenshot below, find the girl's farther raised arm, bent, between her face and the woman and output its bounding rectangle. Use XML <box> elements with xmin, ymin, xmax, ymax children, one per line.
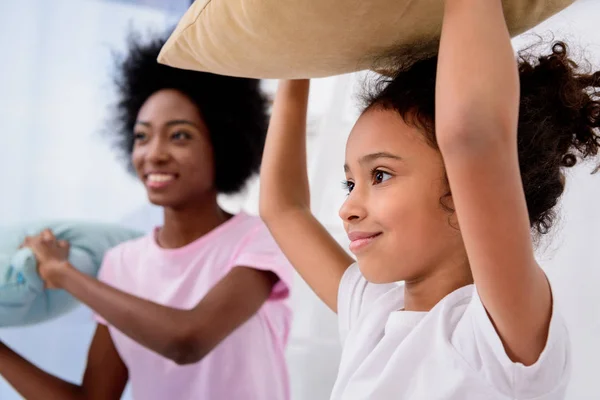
<box><xmin>260</xmin><ymin>80</ymin><xmax>354</xmax><ymax>312</ymax></box>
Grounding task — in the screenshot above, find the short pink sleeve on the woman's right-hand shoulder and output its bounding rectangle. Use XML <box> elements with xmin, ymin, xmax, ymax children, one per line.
<box><xmin>231</xmin><ymin>220</ymin><xmax>294</xmax><ymax>300</ymax></box>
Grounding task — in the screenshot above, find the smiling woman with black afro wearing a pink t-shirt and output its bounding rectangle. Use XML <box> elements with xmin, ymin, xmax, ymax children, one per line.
<box><xmin>0</xmin><ymin>32</ymin><xmax>293</xmax><ymax>400</ymax></box>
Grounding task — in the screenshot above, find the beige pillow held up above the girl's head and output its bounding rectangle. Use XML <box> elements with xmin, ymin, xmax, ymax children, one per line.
<box><xmin>158</xmin><ymin>0</ymin><xmax>574</xmax><ymax>79</ymax></box>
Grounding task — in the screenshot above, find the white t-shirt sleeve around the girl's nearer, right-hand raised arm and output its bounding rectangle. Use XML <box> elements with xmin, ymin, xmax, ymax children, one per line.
<box><xmin>452</xmin><ymin>289</ymin><xmax>571</xmax><ymax>399</ymax></box>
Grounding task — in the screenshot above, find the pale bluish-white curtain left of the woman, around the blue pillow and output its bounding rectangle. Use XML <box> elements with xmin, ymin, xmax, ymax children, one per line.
<box><xmin>0</xmin><ymin>0</ymin><xmax>189</xmax><ymax>400</ymax></box>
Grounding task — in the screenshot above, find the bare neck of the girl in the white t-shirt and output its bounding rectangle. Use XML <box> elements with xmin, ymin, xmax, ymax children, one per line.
<box><xmin>404</xmin><ymin>256</ymin><xmax>473</xmax><ymax>311</ymax></box>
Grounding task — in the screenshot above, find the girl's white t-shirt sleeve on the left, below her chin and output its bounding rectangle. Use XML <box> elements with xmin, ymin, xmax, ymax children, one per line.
<box><xmin>337</xmin><ymin>263</ymin><xmax>399</xmax><ymax>345</ymax></box>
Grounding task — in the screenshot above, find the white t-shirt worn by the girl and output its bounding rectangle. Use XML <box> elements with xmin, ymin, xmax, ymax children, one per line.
<box><xmin>331</xmin><ymin>264</ymin><xmax>571</xmax><ymax>400</ymax></box>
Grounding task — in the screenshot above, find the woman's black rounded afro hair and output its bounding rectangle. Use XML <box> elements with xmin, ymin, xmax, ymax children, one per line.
<box><xmin>112</xmin><ymin>30</ymin><xmax>268</xmax><ymax>194</ymax></box>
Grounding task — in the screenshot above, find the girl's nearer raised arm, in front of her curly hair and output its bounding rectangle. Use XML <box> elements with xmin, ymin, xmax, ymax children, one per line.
<box><xmin>436</xmin><ymin>0</ymin><xmax>552</xmax><ymax>364</ymax></box>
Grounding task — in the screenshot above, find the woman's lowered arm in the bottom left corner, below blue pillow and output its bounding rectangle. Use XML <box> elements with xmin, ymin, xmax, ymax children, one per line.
<box><xmin>0</xmin><ymin>325</ymin><xmax>128</xmax><ymax>400</ymax></box>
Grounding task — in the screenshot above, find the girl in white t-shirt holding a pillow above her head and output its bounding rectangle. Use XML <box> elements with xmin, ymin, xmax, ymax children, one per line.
<box><xmin>260</xmin><ymin>0</ymin><xmax>600</xmax><ymax>400</ymax></box>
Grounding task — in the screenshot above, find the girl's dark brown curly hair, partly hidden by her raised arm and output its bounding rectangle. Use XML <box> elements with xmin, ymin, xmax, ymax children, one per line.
<box><xmin>363</xmin><ymin>42</ymin><xmax>600</xmax><ymax>234</ymax></box>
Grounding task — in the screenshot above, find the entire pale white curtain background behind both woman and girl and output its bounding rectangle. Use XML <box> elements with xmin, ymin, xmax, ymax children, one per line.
<box><xmin>0</xmin><ymin>0</ymin><xmax>600</xmax><ymax>400</ymax></box>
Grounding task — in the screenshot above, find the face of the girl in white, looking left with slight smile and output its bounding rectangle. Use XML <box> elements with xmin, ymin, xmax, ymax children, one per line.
<box><xmin>340</xmin><ymin>107</ymin><xmax>466</xmax><ymax>283</ymax></box>
